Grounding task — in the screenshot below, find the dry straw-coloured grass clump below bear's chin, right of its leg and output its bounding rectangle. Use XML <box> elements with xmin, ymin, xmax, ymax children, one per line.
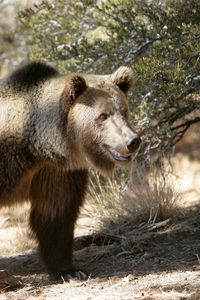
<box><xmin>86</xmin><ymin>163</ymin><xmax>180</xmax><ymax>233</ymax></box>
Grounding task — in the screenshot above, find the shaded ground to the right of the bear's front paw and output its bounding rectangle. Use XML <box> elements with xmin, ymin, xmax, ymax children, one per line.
<box><xmin>75</xmin><ymin>208</ymin><xmax>200</xmax><ymax>277</ymax></box>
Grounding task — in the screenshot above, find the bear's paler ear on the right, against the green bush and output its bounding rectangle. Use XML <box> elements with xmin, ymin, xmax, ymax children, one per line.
<box><xmin>111</xmin><ymin>66</ymin><xmax>133</xmax><ymax>94</ymax></box>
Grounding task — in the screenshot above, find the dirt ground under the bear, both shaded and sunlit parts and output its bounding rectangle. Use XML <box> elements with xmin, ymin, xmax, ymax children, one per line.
<box><xmin>0</xmin><ymin>205</ymin><xmax>200</xmax><ymax>300</ymax></box>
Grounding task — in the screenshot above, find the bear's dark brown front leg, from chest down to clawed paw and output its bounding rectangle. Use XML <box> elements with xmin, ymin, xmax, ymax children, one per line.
<box><xmin>30</xmin><ymin>171</ymin><xmax>87</xmax><ymax>280</ymax></box>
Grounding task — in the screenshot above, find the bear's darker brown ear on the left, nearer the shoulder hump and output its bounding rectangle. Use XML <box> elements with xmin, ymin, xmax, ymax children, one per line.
<box><xmin>65</xmin><ymin>74</ymin><xmax>87</xmax><ymax>102</ymax></box>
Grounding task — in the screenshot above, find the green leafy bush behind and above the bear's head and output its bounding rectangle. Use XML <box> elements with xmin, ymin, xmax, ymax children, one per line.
<box><xmin>19</xmin><ymin>0</ymin><xmax>200</xmax><ymax>158</ymax></box>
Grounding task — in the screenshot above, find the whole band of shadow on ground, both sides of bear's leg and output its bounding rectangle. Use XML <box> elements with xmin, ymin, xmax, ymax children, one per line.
<box><xmin>0</xmin><ymin>208</ymin><xmax>200</xmax><ymax>286</ymax></box>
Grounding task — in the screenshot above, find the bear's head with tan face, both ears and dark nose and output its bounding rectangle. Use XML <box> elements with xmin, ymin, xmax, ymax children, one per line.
<box><xmin>65</xmin><ymin>67</ymin><xmax>141</xmax><ymax>173</ymax></box>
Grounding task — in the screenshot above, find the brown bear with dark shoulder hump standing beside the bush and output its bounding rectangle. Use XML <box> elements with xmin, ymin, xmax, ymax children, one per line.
<box><xmin>0</xmin><ymin>62</ymin><xmax>141</xmax><ymax>280</ymax></box>
